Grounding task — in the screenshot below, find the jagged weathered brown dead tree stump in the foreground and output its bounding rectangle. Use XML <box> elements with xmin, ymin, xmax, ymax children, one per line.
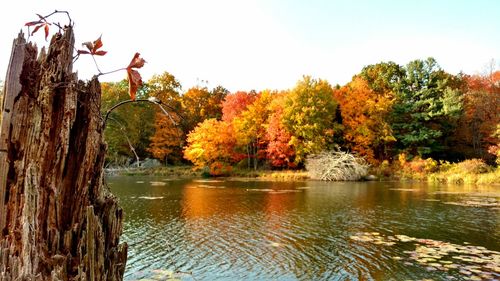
<box><xmin>0</xmin><ymin>28</ymin><xmax>127</xmax><ymax>281</ymax></box>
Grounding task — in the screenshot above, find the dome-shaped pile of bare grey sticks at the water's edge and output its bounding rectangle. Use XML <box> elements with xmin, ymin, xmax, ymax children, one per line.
<box><xmin>306</xmin><ymin>150</ymin><xmax>369</xmax><ymax>181</ymax></box>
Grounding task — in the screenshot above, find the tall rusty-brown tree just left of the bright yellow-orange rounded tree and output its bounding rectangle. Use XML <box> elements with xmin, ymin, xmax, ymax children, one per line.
<box><xmin>146</xmin><ymin>72</ymin><xmax>185</xmax><ymax>163</ymax></box>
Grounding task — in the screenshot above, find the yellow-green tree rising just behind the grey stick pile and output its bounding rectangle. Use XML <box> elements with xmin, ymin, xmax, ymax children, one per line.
<box><xmin>283</xmin><ymin>76</ymin><xmax>337</xmax><ymax>163</ymax></box>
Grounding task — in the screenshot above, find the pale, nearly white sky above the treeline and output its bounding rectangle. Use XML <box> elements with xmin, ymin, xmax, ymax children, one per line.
<box><xmin>0</xmin><ymin>0</ymin><xmax>500</xmax><ymax>92</ymax></box>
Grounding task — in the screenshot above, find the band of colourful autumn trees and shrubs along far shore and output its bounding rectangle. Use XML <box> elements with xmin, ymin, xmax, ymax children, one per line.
<box><xmin>102</xmin><ymin>58</ymin><xmax>500</xmax><ymax>179</ymax></box>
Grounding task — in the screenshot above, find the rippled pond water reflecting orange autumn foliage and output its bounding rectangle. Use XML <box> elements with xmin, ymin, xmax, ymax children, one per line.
<box><xmin>108</xmin><ymin>177</ymin><xmax>500</xmax><ymax>280</ymax></box>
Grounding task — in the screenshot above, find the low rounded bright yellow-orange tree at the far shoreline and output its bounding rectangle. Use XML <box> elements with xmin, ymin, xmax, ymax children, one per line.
<box><xmin>184</xmin><ymin>118</ymin><xmax>236</xmax><ymax>174</ymax></box>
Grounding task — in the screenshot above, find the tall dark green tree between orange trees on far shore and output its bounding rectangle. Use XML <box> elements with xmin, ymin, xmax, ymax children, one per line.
<box><xmin>392</xmin><ymin>58</ymin><xmax>462</xmax><ymax>155</ymax></box>
